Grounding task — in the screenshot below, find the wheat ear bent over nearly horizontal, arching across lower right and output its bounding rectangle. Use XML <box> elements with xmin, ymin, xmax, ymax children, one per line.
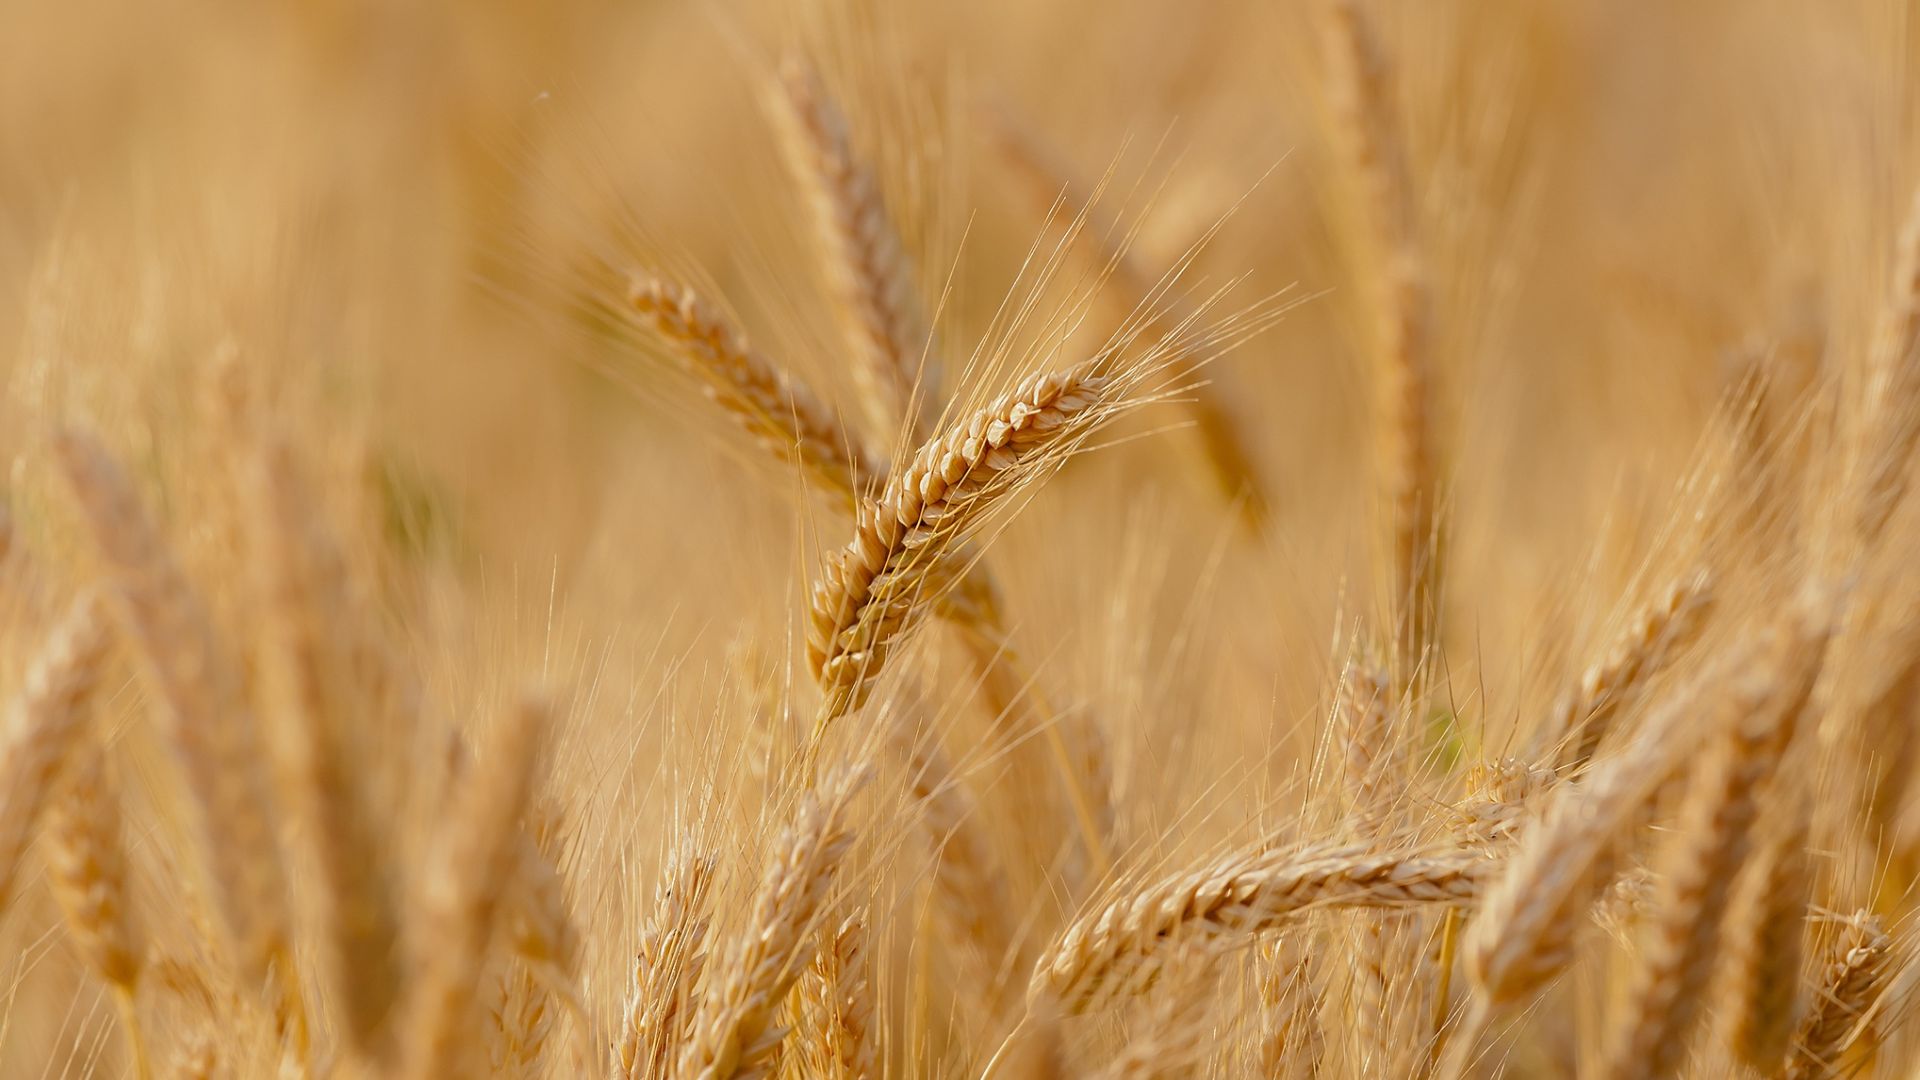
<box><xmin>1027</xmin><ymin>846</ymin><xmax>1490</xmax><ymax>1013</ymax></box>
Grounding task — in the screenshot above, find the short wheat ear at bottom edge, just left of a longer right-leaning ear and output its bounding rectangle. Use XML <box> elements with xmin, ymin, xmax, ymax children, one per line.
<box><xmin>614</xmin><ymin>844</ymin><xmax>714</xmax><ymax>1080</ymax></box>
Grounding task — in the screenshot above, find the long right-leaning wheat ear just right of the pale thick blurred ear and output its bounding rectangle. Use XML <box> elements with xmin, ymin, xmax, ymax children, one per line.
<box><xmin>1607</xmin><ymin>603</ymin><xmax>1832</xmax><ymax>1080</ymax></box>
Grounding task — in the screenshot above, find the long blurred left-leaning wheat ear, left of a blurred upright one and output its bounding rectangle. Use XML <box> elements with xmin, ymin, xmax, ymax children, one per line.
<box><xmin>56</xmin><ymin>432</ymin><xmax>298</xmax><ymax>991</ymax></box>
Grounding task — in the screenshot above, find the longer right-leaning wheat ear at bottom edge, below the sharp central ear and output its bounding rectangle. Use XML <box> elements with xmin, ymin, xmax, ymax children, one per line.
<box><xmin>676</xmin><ymin>771</ymin><xmax>866</xmax><ymax>1080</ymax></box>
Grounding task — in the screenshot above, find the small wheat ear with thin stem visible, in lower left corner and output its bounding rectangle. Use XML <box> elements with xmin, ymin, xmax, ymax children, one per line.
<box><xmin>46</xmin><ymin>736</ymin><xmax>148</xmax><ymax>1080</ymax></box>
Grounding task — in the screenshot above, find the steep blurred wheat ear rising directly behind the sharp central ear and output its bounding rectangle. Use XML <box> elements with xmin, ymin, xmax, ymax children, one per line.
<box><xmin>776</xmin><ymin>56</ymin><xmax>935</xmax><ymax>440</ymax></box>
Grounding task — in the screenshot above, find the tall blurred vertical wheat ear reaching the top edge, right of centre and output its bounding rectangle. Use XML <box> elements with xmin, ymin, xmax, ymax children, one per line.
<box><xmin>1327</xmin><ymin>0</ymin><xmax>1440</xmax><ymax>680</ymax></box>
